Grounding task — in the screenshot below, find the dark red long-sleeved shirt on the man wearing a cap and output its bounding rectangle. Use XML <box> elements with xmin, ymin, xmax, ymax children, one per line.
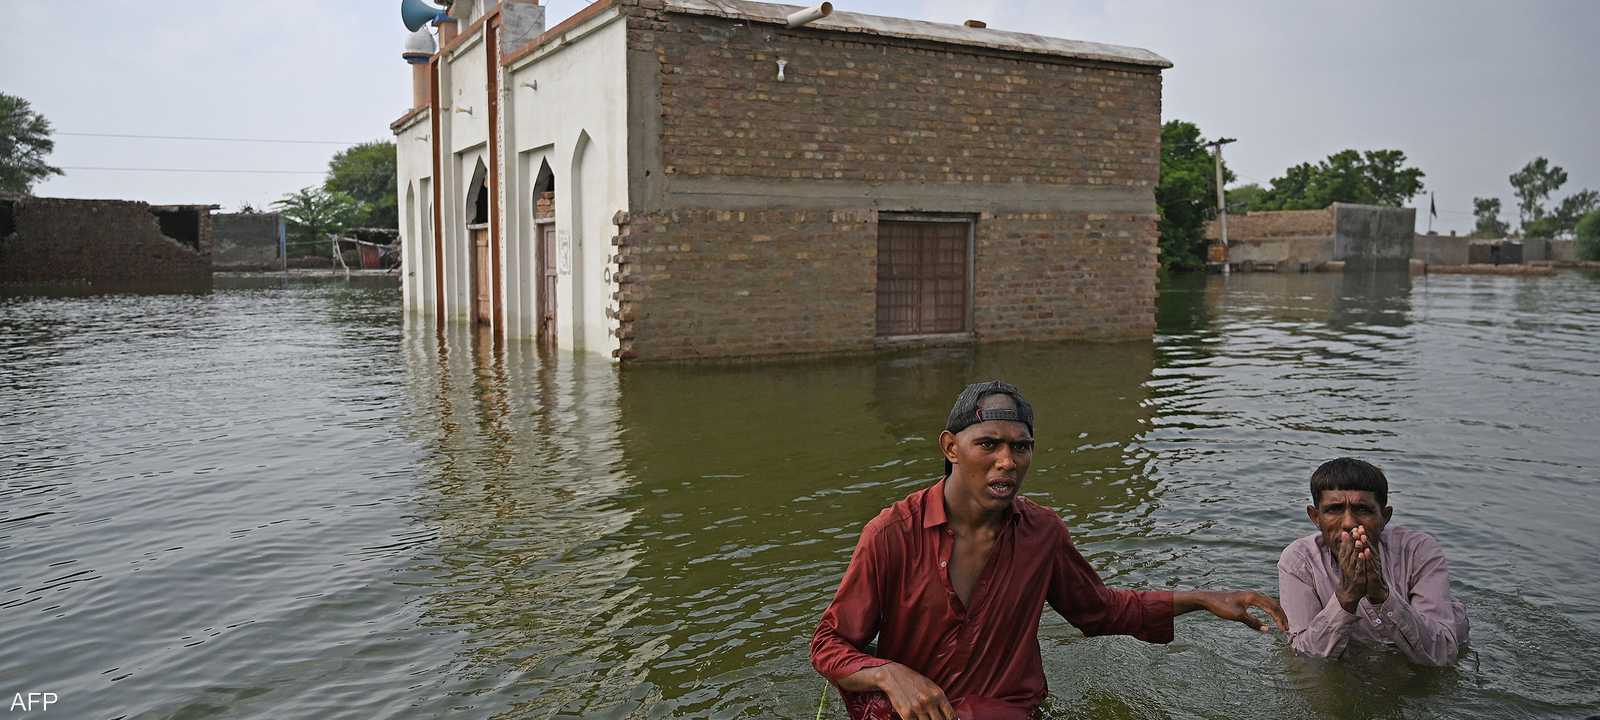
<box><xmin>811</xmin><ymin>480</ymin><xmax>1173</xmax><ymax>717</ymax></box>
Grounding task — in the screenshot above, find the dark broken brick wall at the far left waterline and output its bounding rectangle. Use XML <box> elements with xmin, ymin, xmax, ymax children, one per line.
<box><xmin>0</xmin><ymin>198</ymin><xmax>213</xmax><ymax>290</ymax></box>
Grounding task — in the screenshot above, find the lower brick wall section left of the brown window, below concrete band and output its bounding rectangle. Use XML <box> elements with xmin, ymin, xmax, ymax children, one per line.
<box><xmin>614</xmin><ymin>210</ymin><xmax>877</xmax><ymax>360</ymax></box>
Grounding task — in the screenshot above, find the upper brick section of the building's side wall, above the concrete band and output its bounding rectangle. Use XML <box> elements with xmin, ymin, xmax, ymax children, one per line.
<box><xmin>634</xmin><ymin>13</ymin><xmax>1162</xmax><ymax>187</ymax></box>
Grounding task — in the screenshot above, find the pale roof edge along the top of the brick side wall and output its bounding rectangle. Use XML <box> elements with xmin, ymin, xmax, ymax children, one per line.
<box><xmin>664</xmin><ymin>0</ymin><xmax>1173</xmax><ymax>69</ymax></box>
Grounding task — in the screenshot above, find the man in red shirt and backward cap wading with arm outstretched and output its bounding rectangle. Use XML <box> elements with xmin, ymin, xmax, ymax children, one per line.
<box><xmin>811</xmin><ymin>381</ymin><xmax>1288</xmax><ymax>720</ymax></box>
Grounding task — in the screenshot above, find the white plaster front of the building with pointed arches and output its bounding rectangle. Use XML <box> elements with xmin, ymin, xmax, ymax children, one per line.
<box><xmin>392</xmin><ymin>0</ymin><xmax>629</xmax><ymax>357</ymax></box>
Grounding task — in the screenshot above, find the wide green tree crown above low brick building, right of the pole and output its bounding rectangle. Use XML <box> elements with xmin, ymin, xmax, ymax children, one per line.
<box><xmin>1254</xmin><ymin>150</ymin><xmax>1426</xmax><ymax>210</ymax></box>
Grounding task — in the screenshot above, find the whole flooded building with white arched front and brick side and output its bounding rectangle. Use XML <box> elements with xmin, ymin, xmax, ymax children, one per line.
<box><xmin>392</xmin><ymin>0</ymin><xmax>1171</xmax><ymax>360</ymax></box>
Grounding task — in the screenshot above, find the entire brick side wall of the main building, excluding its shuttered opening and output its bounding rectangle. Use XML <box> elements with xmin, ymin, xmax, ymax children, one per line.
<box><xmin>611</xmin><ymin>8</ymin><xmax>1162</xmax><ymax>360</ymax></box>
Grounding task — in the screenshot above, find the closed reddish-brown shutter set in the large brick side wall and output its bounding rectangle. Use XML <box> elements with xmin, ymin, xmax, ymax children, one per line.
<box><xmin>877</xmin><ymin>221</ymin><xmax>971</xmax><ymax>338</ymax></box>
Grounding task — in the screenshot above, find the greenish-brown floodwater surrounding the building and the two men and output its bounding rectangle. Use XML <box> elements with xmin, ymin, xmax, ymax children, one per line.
<box><xmin>0</xmin><ymin>272</ymin><xmax>1600</xmax><ymax>718</ymax></box>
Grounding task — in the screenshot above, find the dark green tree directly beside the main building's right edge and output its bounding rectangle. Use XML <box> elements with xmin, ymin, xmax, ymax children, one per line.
<box><xmin>1155</xmin><ymin>120</ymin><xmax>1234</xmax><ymax>270</ymax></box>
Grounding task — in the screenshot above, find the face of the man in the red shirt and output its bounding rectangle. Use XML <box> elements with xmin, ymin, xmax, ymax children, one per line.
<box><xmin>939</xmin><ymin>395</ymin><xmax>1034</xmax><ymax>510</ymax></box>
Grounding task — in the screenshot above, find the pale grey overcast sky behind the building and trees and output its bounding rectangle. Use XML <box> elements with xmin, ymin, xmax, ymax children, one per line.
<box><xmin>0</xmin><ymin>0</ymin><xmax>1600</xmax><ymax>232</ymax></box>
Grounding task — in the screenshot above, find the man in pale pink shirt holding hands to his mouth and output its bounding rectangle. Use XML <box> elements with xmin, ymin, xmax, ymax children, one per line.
<box><xmin>1278</xmin><ymin>458</ymin><xmax>1467</xmax><ymax>666</ymax></box>
